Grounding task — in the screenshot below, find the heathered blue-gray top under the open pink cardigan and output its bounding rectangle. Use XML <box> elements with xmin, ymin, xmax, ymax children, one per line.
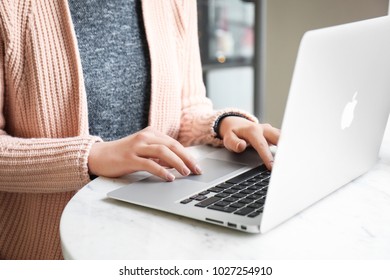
<box><xmin>68</xmin><ymin>0</ymin><xmax>151</xmax><ymax>140</ymax></box>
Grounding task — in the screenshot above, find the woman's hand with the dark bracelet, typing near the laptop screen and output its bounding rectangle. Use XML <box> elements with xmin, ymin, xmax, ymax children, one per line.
<box><xmin>219</xmin><ymin>116</ymin><xmax>280</xmax><ymax>170</ymax></box>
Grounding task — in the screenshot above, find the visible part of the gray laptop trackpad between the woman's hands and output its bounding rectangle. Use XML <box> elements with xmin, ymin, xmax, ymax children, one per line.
<box><xmin>184</xmin><ymin>158</ymin><xmax>245</xmax><ymax>183</ymax></box>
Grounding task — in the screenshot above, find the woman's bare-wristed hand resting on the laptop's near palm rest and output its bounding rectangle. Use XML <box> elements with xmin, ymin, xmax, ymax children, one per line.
<box><xmin>88</xmin><ymin>127</ymin><xmax>201</xmax><ymax>181</ymax></box>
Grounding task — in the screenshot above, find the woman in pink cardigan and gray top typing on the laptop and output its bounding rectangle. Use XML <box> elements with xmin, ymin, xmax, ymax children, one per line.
<box><xmin>0</xmin><ymin>0</ymin><xmax>279</xmax><ymax>259</ymax></box>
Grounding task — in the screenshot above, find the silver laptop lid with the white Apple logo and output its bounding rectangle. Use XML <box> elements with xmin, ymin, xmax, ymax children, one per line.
<box><xmin>260</xmin><ymin>16</ymin><xmax>390</xmax><ymax>232</ymax></box>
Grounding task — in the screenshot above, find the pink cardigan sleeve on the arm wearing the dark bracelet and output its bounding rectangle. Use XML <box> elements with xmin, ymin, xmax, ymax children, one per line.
<box><xmin>177</xmin><ymin>1</ymin><xmax>258</xmax><ymax>146</ymax></box>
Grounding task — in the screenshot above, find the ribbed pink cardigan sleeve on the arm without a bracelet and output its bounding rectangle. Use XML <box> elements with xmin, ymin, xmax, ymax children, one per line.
<box><xmin>0</xmin><ymin>14</ymin><xmax>101</xmax><ymax>193</ymax></box>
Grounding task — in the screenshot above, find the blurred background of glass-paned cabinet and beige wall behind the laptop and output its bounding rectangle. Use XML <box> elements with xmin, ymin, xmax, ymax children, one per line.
<box><xmin>197</xmin><ymin>0</ymin><xmax>390</xmax><ymax>127</ymax></box>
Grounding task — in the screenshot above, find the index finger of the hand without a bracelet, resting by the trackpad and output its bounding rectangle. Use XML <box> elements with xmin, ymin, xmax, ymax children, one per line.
<box><xmin>148</xmin><ymin>132</ymin><xmax>202</xmax><ymax>174</ymax></box>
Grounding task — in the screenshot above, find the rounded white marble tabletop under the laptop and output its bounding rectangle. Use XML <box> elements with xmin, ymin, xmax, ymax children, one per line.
<box><xmin>60</xmin><ymin>117</ymin><xmax>390</xmax><ymax>260</ymax></box>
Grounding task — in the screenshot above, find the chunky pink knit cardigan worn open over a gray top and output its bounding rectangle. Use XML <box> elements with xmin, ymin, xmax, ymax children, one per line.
<box><xmin>0</xmin><ymin>0</ymin><xmax>255</xmax><ymax>259</ymax></box>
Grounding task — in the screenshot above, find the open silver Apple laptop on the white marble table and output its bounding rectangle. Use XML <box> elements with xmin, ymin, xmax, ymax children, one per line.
<box><xmin>108</xmin><ymin>17</ymin><xmax>390</xmax><ymax>233</ymax></box>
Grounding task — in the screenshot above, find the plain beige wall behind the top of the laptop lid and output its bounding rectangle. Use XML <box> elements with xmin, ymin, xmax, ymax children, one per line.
<box><xmin>261</xmin><ymin>0</ymin><xmax>390</xmax><ymax>127</ymax></box>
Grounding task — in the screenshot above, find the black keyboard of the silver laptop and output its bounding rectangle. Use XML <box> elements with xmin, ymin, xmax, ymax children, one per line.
<box><xmin>180</xmin><ymin>165</ymin><xmax>271</xmax><ymax>218</ymax></box>
